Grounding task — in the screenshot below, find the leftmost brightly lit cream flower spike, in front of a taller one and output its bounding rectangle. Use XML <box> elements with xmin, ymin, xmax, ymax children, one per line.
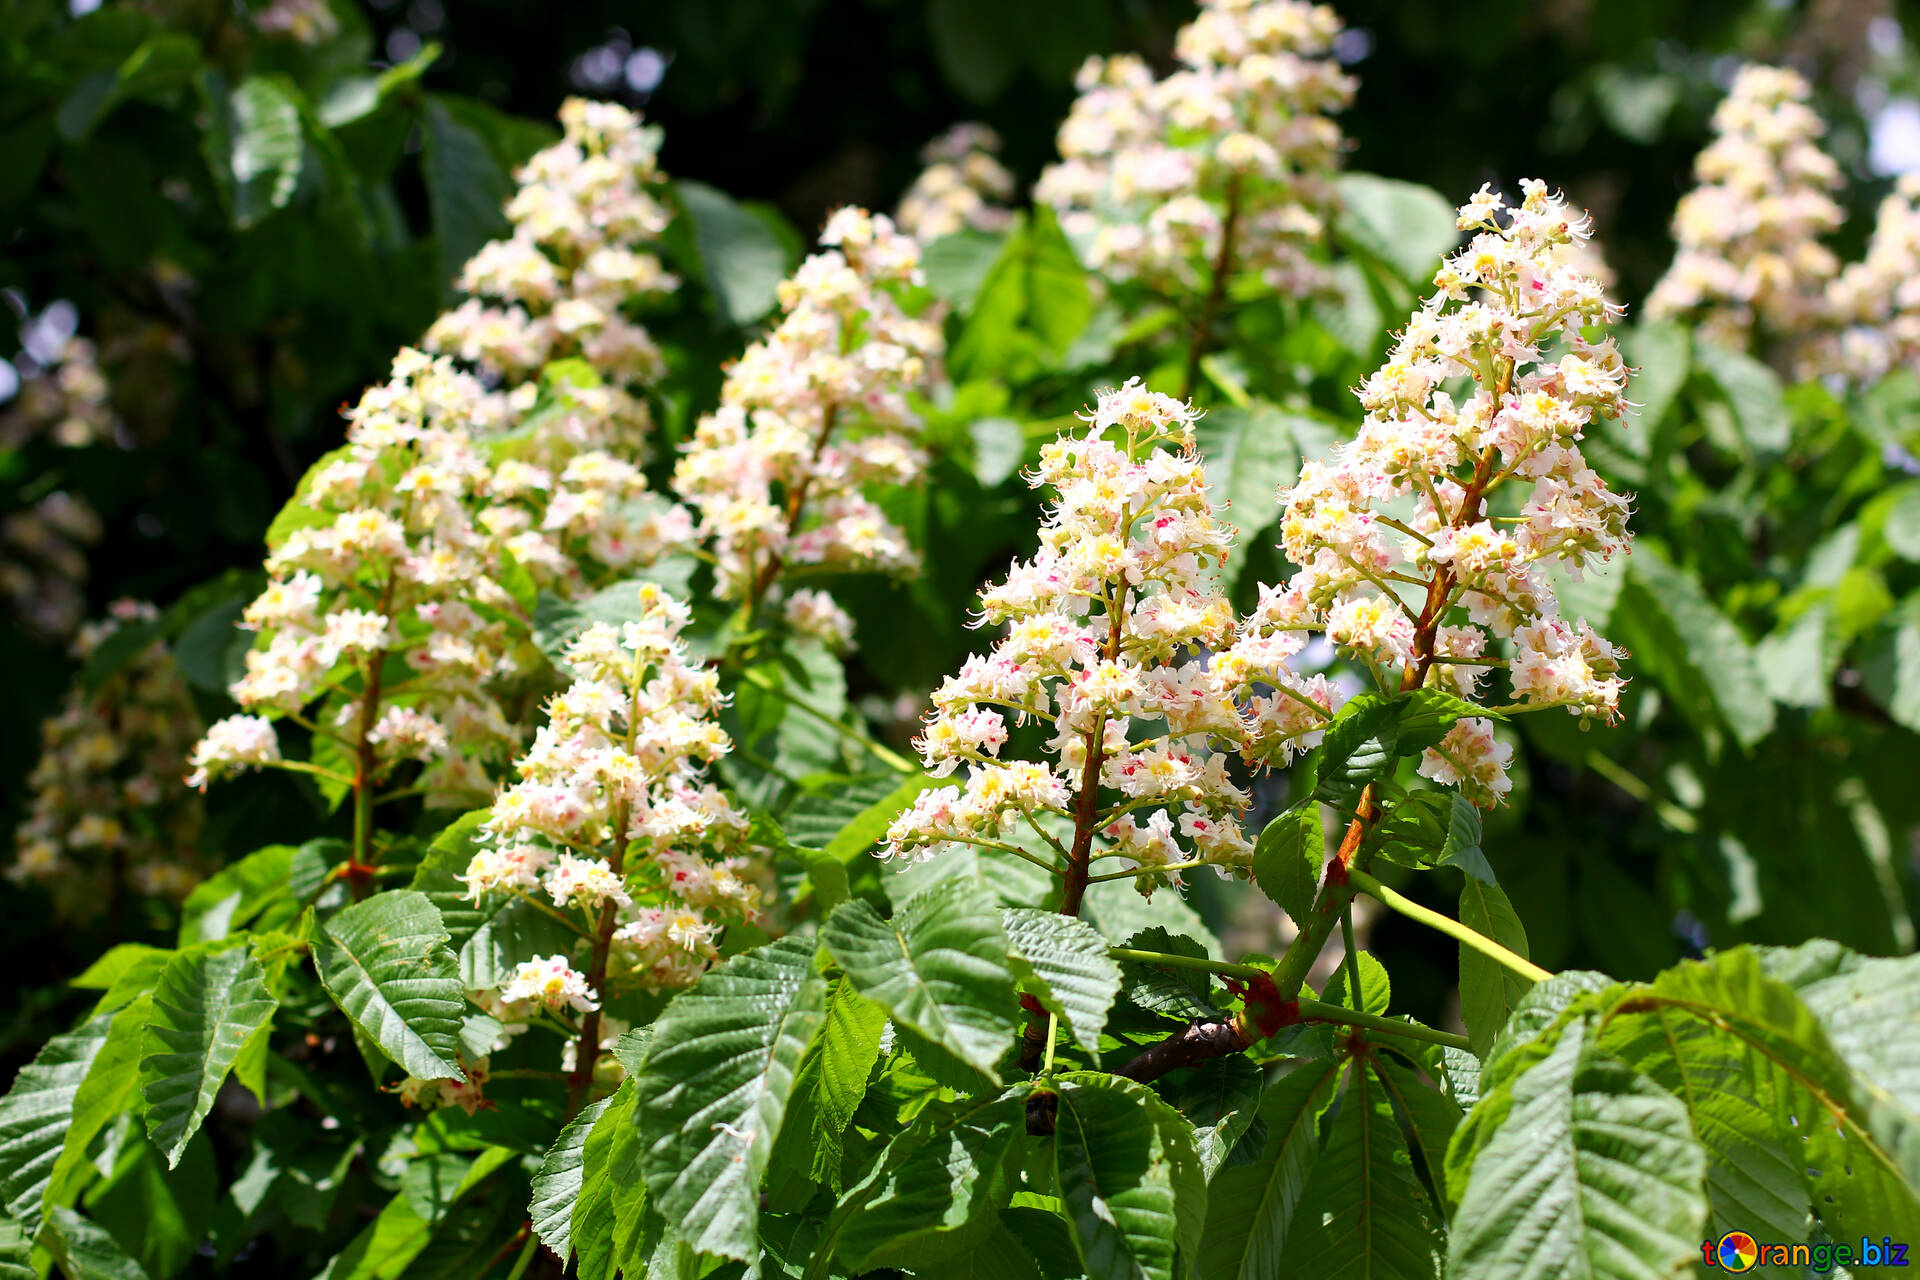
<box><xmin>188</xmin><ymin>349</ymin><xmax>520</xmax><ymax>806</ymax></box>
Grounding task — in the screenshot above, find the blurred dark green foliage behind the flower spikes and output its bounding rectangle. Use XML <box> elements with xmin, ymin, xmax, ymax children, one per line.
<box><xmin>0</xmin><ymin>0</ymin><xmax>1920</xmax><ymax>1061</ymax></box>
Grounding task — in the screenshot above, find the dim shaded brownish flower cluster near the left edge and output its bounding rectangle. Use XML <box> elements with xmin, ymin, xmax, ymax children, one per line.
<box><xmin>6</xmin><ymin>601</ymin><xmax>204</xmax><ymax>919</ymax></box>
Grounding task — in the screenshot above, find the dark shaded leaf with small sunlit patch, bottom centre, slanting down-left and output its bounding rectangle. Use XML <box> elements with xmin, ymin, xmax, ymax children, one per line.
<box><xmin>835</xmin><ymin>1090</ymin><xmax>1027</xmax><ymax>1270</ymax></box>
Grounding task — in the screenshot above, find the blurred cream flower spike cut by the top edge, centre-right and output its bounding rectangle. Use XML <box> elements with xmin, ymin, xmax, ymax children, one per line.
<box><xmin>1033</xmin><ymin>0</ymin><xmax>1354</xmax><ymax>294</ymax></box>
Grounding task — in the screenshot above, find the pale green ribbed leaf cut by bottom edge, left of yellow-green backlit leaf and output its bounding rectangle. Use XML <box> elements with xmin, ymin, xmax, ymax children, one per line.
<box><xmin>1448</xmin><ymin>1021</ymin><xmax>1707</xmax><ymax>1280</ymax></box>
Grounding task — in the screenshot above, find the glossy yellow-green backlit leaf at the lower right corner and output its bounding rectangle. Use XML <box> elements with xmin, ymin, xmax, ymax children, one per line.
<box><xmin>1601</xmin><ymin>948</ymin><xmax>1920</xmax><ymax>1238</ymax></box>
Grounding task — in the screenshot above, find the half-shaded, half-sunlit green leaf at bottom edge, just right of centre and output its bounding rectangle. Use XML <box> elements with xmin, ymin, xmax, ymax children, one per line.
<box><xmin>1054</xmin><ymin>1073</ymin><xmax>1206</xmax><ymax>1280</ymax></box>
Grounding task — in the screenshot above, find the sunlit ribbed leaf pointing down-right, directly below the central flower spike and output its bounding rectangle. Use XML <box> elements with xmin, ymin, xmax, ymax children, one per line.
<box><xmin>820</xmin><ymin>877</ymin><xmax>1018</xmax><ymax>1082</ymax></box>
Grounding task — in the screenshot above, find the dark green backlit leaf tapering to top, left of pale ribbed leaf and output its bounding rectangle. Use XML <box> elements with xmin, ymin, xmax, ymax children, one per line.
<box><xmin>1279</xmin><ymin>1065</ymin><xmax>1446</xmax><ymax>1280</ymax></box>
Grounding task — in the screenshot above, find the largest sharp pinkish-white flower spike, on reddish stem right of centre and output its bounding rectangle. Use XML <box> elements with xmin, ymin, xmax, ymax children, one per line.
<box><xmin>1259</xmin><ymin>180</ymin><xmax>1628</xmax><ymax>806</ymax></box>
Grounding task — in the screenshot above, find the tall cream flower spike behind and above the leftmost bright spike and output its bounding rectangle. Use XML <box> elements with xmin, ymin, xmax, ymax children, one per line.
<box><xmin>426</xmin><ymin>98</ymin><xmax>680</xmax><ymax>429</ymax></box>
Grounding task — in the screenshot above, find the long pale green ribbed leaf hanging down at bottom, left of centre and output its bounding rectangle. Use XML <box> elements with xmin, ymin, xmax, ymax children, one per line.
<box><xmin>636</xmin><ymin>936</ymin><xmax>829</xmax><ymax>1259</ymax></box>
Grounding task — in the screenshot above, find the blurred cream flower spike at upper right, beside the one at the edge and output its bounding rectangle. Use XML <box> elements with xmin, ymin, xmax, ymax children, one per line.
<box><xmin>1647</xmin><ymin>65</ymin><xmax>1841</xmax><ymax>349</ymax></box>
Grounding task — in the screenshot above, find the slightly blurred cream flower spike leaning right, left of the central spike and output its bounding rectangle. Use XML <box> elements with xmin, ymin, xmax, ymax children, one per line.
<box><xmin>674</xmin><ymin>207</ymin><xmax>943</xmax><ymax>628</ymax></box>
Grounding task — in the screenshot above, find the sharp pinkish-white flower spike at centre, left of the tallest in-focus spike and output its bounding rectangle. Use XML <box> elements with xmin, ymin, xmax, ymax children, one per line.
<box><xmin>883</xmin><ymin>378</ymin><xmax>1254</xmax><ymax>912</ymax></box>
